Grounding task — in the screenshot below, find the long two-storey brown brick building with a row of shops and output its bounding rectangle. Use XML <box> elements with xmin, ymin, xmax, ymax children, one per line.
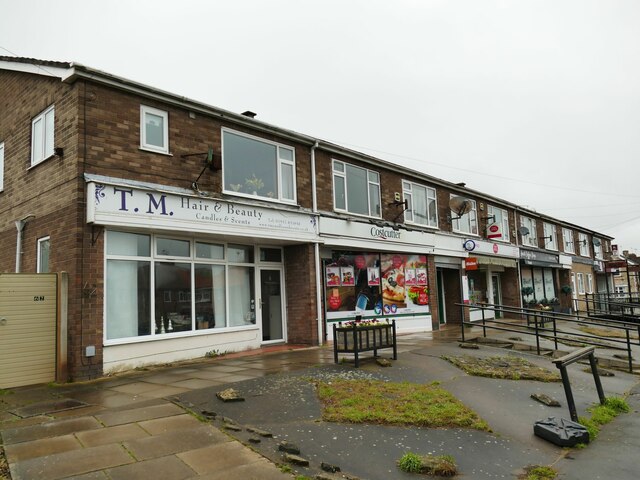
<box><xmin>0</xmin><ymin>57</ymin><xmax>611</xmax><ymax>380</ymax></box>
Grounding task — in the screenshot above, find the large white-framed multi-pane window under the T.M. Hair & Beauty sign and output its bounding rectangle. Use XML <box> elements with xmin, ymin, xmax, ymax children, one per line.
<box><xmin>105</xmin><ymin>231</ymin><xmax>260</xmax><ymax>340</ymax></box>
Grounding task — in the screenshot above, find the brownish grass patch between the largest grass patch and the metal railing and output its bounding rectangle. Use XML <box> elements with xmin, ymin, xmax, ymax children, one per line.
<box><xmin>442</xmin><ymin>355</ymin><xmax>560</xmax><ymax>382</ymax></box>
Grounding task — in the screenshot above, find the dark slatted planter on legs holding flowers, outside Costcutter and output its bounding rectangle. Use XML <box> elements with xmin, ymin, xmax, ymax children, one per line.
<box><xmin>333</xmin><ymin>319</ymin><xmax>398</xmax><ymax>368</ymax></box>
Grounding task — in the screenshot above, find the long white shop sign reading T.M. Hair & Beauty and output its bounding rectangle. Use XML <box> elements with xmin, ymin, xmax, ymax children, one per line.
<box><xmin>87</xmin><ymin>182</ymin><xmax>317</xmax><ymax>240</ymax></box>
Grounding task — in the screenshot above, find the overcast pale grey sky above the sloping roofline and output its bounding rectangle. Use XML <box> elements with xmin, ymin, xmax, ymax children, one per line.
<box><xmin>0</xmin><ymin>0</ymin><xmax>640</xmax><ymax>253</ymax></box>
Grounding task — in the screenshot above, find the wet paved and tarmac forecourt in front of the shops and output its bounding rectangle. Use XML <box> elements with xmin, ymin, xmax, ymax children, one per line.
<box><xmin>0</xmin><ymin>322</ymin><xmax>640</xmax><ymax>480</ymax></box>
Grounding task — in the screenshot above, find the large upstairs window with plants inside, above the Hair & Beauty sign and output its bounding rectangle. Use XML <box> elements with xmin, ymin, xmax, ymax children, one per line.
<box><xmin>222</xmin><ymin>130</ymin><xmax>296</xmax><ymax>203</ymax></box>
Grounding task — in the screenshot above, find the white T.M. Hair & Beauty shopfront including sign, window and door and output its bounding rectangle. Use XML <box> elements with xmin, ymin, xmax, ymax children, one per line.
<box><xmin>87</xmin><ymin>177</ymin><xmax>318</xmax><ymax>373</ymax></box>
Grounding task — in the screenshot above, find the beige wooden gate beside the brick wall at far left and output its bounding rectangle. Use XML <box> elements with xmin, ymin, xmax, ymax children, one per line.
<box><xmin>0</xmin><ymin>273</ymin><xmax>66</xmax><ymax>388</ymax></box>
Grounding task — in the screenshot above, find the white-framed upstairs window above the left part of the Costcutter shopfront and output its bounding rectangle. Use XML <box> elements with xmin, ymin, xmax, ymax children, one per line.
<box><xmin>333</xmin><ymin>160</ymin><xmax>382</xmax><ymax>217</ymax></box>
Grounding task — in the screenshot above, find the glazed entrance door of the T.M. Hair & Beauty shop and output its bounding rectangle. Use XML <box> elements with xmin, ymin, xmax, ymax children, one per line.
<box><xmin>260</xmin><ymin>268</ymin><xmax>284</xmax><ymax>343</ymax></box>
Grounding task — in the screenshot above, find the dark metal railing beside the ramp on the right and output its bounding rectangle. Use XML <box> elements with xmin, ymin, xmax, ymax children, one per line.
<box><xmin>456</xmin><ymin>304</ymin><xmax>640</xmax><ymax>373</ymax></box>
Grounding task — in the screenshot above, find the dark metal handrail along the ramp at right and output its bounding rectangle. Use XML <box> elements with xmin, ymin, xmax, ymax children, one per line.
<box><xmin>456</xmin><ymin>303</ymin><xmax>640</xmax><ymax>373</ymax></box>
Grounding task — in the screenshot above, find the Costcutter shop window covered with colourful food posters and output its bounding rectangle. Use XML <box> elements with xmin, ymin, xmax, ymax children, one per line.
<box><xmin>324</xmin><ymin>252</ymin><xmax>429</xmax><ymax>321</ymax></box>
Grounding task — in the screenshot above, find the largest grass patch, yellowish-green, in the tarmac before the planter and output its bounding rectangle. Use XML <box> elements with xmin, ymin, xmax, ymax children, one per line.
<box><xmin>316</xmin><ymin>380</ymin><xmax>490</xmax><ymax>431</ymax></box>
